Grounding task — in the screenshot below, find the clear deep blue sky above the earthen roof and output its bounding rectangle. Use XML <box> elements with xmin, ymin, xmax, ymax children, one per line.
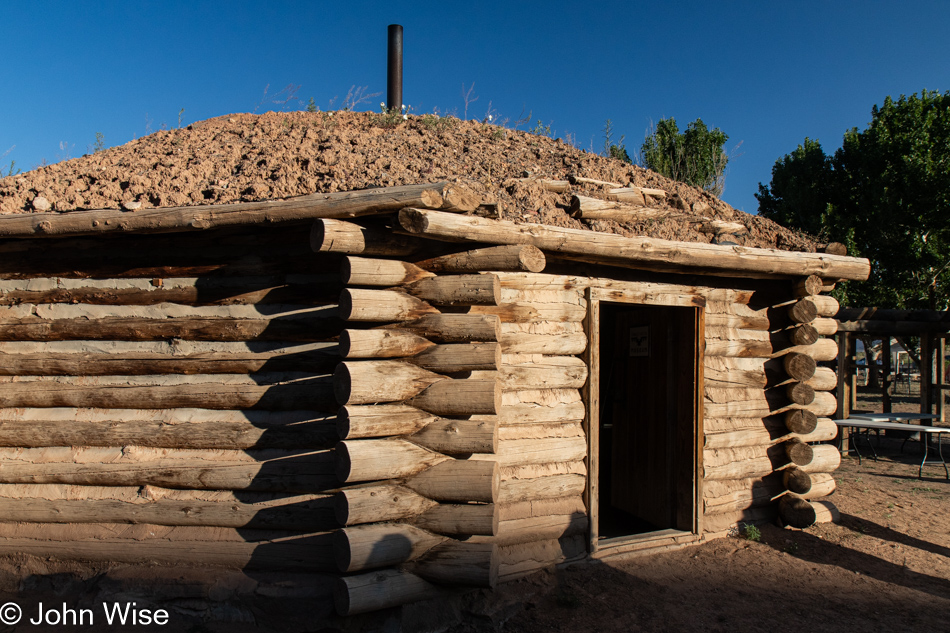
<box><xmin>0</xmin><ymin>0</ymin><xmax>950</xmax><ymax>212</ymax></box>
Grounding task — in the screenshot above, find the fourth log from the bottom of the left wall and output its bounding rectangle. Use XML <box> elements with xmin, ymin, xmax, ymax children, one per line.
<box><xmin>0</xmin><ymin>408</ymin><xmax>336</xmax><ymax>450</ymax></box>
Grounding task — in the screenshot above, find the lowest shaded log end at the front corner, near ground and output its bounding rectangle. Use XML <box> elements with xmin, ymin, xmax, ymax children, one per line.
<box><xmin>333</xmin><ymin>569</ymin><xmax>444</xmax><ymax>616</ymax></box>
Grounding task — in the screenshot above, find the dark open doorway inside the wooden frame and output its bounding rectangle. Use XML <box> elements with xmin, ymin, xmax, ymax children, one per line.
<box><xmin>598</xmin><ymin>302</ymin><xmax>699</xmax><ymax>539</ymax></box>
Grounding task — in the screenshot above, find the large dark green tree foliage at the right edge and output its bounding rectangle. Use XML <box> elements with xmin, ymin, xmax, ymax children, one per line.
<box><xmin>756</xmin><ymin>91</ymin><xmax>950</xmax><ymax>310</ymax></box>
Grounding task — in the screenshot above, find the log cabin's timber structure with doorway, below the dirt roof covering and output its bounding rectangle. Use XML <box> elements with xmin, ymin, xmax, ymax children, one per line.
<box><xmin>0</xmin><ymin>182</ymin><xmax>869</xmax><ymax>616</ymax></box>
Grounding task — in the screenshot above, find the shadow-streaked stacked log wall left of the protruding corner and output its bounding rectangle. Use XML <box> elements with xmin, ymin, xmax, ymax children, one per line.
<box><xmin>0</xmin><ymin>226</ymin><xmax>343</xmax><ymax>576</ymax></box>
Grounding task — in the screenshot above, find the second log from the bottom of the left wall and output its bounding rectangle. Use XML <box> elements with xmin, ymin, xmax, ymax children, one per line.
<box><xmin>0</xmin><ymin>484</ymin><xmax>337</xmax><ymax>532</ymax></box>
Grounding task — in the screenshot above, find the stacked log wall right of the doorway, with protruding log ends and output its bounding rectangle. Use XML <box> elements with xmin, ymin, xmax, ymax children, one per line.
<box><xmin>703</xmin><ymin>276</ymin><xmax>840</xmax><ymax>533</ymax></box>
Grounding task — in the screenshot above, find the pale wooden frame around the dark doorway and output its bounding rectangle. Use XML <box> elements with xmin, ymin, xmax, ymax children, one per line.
<box><xmin>584</xmin><ymin>287</ymin><xmax>706</xmax><ymax>558</ymax></box>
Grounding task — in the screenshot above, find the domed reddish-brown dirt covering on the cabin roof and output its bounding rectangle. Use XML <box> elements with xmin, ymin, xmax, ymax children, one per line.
<box><xmin>0</xmin><ymin>112</ymin><xmax>818</xmax><ymax>252</ymax></box>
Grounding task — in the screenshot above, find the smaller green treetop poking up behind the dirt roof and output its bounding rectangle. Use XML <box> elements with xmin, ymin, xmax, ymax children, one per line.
<box><xmin>640</xmin><ymin>117</ymin><xmax>729</xmax><ymax>197</ymax></box>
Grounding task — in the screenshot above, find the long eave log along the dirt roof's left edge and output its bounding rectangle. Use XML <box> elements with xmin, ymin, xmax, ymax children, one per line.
<box><xmin>0</xmin><ymin>183</ymin><xmax>458</xmax><ymax>237</ymax></box>
